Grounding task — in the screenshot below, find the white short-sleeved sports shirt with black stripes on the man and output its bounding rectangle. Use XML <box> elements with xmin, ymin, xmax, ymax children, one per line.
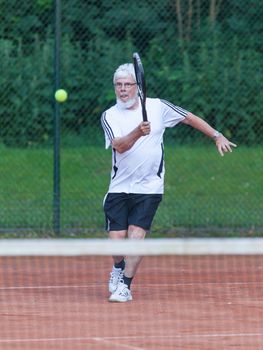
<box><xmin>101</xmin><ymin>98</ymin><xmax>188</xmax><ymax>194</ymax></box>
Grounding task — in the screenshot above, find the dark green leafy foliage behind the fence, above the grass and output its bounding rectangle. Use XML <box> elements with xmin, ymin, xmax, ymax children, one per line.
<box><xmin>0</xmin><ymin>0</ymin><xmax>263</xmax><ymax>146</ymax></box>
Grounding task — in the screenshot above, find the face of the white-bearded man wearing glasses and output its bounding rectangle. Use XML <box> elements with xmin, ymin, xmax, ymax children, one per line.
<box><xmin>114</xmin><ymin>76</ymin><xmax>137</xmax><ymax>108</ymax></box>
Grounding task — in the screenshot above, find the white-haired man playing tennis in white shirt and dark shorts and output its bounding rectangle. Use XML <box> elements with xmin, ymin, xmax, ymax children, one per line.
<box><xmin>101</xmin><ymin>63</ymin><xmax>236</xmax><ymax>302</ymax></box>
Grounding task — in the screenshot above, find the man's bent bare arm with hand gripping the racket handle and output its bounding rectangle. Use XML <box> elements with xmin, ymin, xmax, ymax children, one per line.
<box><xmin>111</xmin><ymin>122</ymin><xmax>151</xmax><ymax>153</ymax></box>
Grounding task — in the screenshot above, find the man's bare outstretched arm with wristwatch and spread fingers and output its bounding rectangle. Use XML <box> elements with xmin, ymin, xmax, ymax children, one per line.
<box><xmin>182</xmin><ymin>113</ymin><xmax>237</xmax><ymax>156</ymax></box>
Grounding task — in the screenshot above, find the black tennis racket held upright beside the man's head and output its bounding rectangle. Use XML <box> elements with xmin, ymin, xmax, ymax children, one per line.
<box><xmin>133</xmin><ymin>52</ymin><xmax>148</xmax><ymax>122</ymax></box>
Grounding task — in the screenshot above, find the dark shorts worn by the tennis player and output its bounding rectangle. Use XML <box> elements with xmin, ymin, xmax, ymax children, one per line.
<box><xmin>104</xmin><ymin>193</ymin><xmax>162</xmax><ymax>231</ymax></box>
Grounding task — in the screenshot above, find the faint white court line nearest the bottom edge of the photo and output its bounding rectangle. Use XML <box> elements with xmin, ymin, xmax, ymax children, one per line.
<box><xmin>0</xmin><ymin>333</ymin><xmax>263</xmax><ymax>344</ymax></box>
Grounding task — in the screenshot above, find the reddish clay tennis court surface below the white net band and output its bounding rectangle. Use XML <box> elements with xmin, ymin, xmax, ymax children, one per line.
<box><xmin>0</xmin><ymin>255</ymin><xmax>263</xmax><ymax>350</ymax></box>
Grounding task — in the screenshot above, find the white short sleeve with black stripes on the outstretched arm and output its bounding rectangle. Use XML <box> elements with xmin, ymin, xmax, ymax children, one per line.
<box><xmin>161</xmin><ymin>100</ymin><xmax>189</xmax><ymax>128</ymax></box>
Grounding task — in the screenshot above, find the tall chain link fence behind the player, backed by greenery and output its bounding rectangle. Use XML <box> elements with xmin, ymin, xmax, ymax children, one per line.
<box><xmin>0</xmin><ymin>0</ymin><xmax>263</xmax><ymax>236</ymax></box>
